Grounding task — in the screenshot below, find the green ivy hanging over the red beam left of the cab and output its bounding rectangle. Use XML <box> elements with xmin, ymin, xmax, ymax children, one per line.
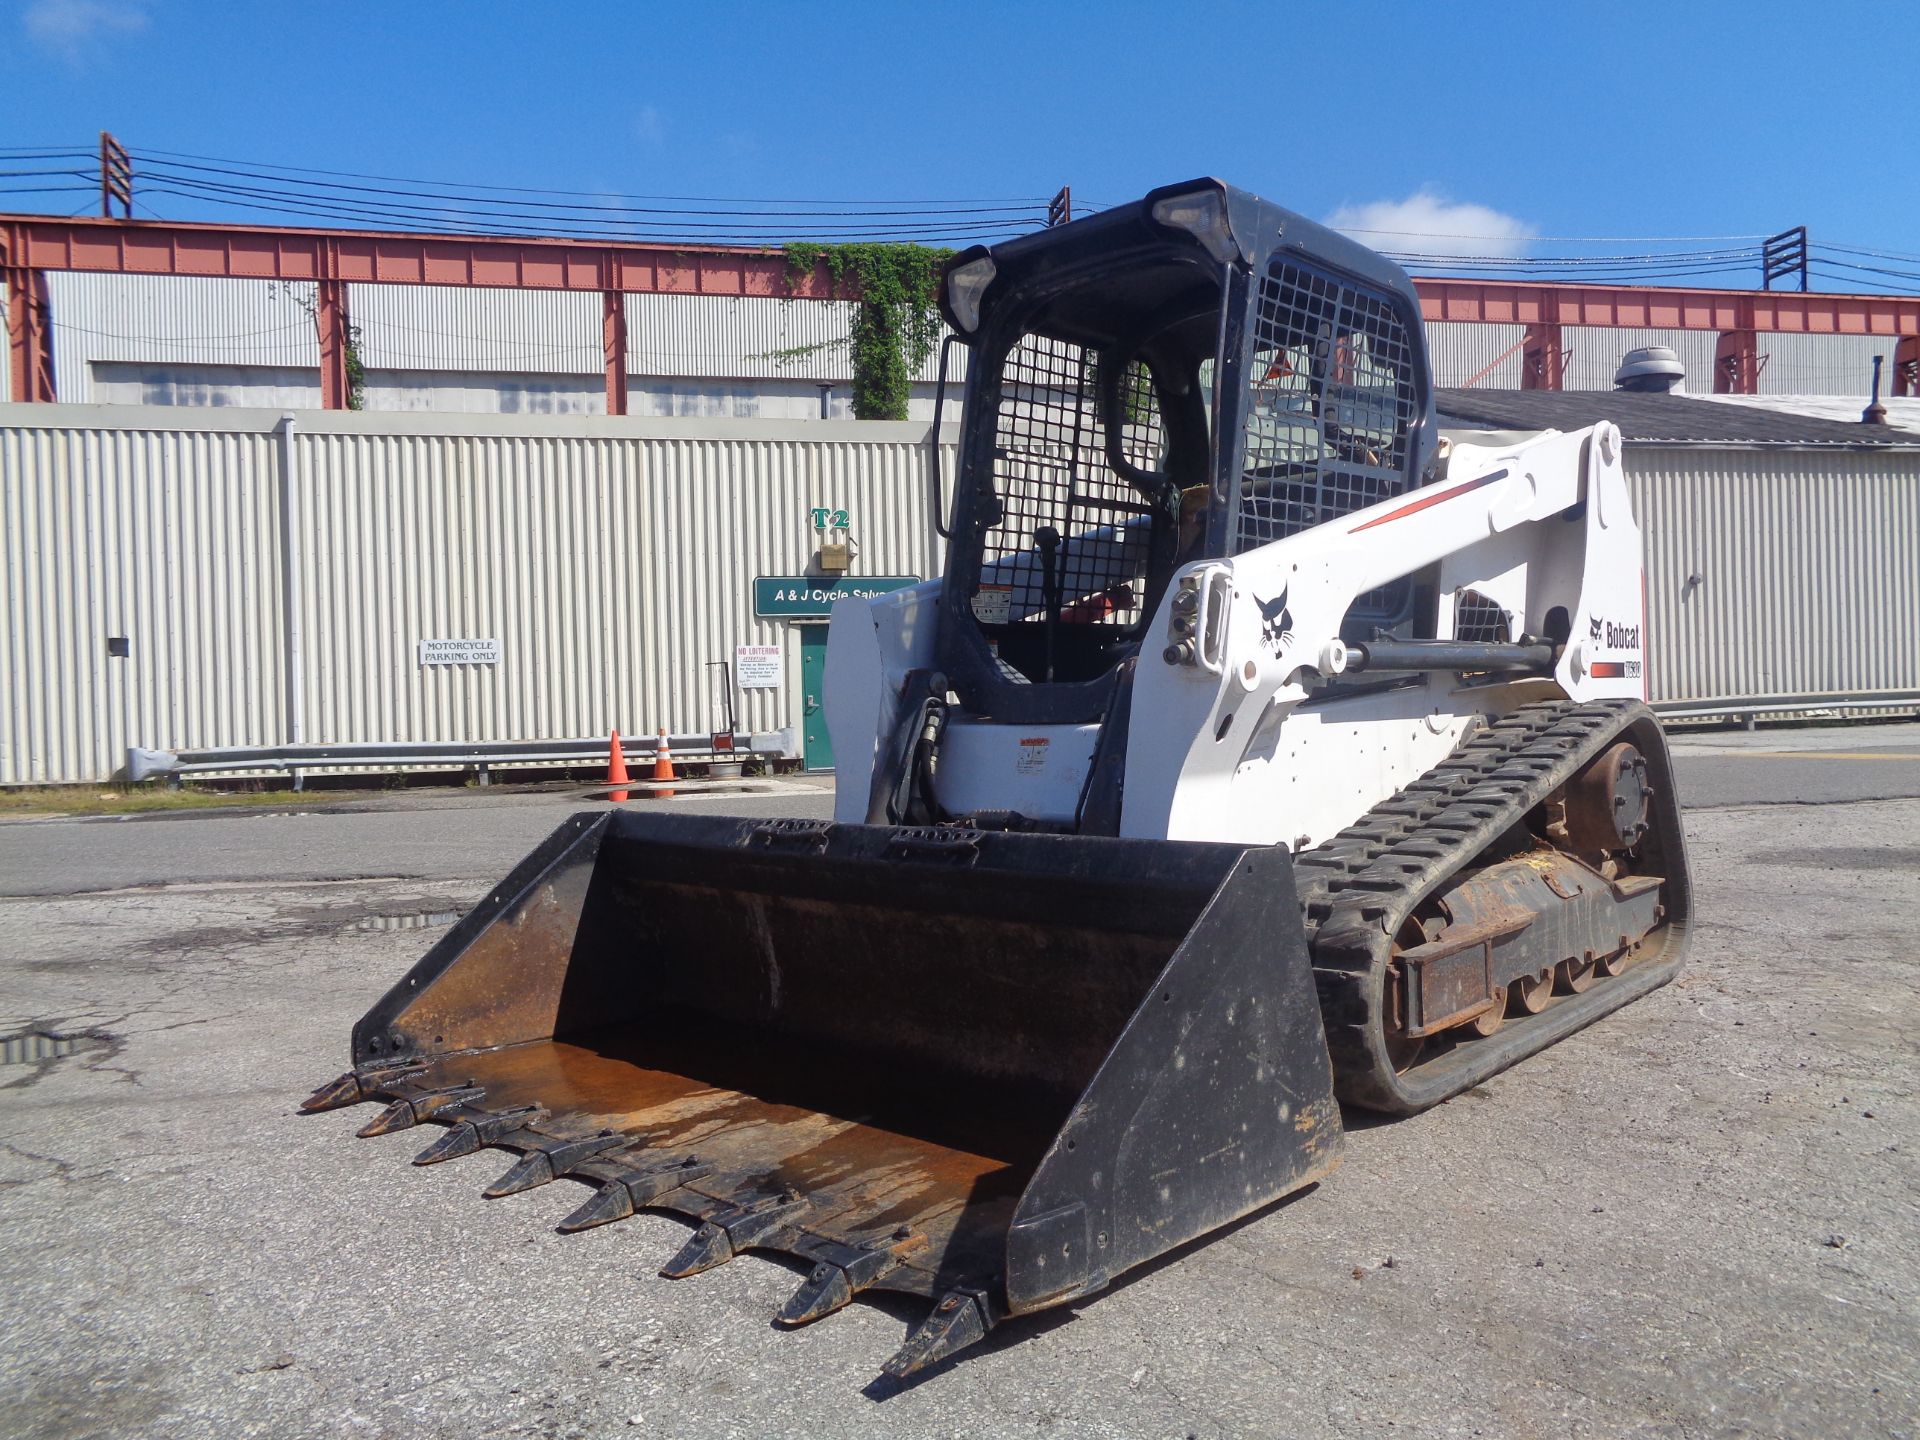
<box><xmin>781</xmin><ymin>240</ymin><xmax>954</xmax><ymax>420</ymax></box>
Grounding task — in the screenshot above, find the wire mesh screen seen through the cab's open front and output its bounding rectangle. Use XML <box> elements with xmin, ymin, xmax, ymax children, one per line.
<box><xmin>972</xmin><ymin>334</ymin><xmax>1167</xmax><ymax>680</ymax></box>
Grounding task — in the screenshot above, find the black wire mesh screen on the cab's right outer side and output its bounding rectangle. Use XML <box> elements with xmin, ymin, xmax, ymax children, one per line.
<box><xmin>1233</xmin><ymin>259</ymin><xmax>1417</xmax><ymax>553</ymax></box>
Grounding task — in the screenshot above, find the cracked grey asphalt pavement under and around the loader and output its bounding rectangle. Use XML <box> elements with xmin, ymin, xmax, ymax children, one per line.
<box><xmin>0</xmin><ymin>756</ymin><xmax>1920</xmax><ymax>1440</ymax></box>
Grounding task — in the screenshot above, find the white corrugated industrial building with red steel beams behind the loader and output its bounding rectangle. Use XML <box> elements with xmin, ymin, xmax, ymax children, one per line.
<box><xmin>0</xmin><ymin>217</ymin><xmax>1920</xmax><ymax>785</ymax></box>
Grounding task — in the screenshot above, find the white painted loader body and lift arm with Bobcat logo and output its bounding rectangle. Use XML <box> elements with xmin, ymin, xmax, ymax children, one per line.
<box><xmin>828</xmin><ymin>424</ymin><xmax>1645</xmax><ymax>851</ymax></box>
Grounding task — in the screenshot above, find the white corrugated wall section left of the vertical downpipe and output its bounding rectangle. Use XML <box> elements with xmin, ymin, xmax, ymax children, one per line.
<box><xmin>0</xmin><ymin>407</ymin><xmax>280</xmax><ymax>785</ymax></box>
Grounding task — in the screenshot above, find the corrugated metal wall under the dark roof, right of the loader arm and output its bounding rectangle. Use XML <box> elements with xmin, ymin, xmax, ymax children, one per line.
<box><xmin>1626</xmin><ymin>445</ymin><xmax>1920</xmax><ymax>701</ymax></box>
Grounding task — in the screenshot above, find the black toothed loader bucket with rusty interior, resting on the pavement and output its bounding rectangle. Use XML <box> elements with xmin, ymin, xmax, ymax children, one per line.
<box><xmin>307</xmin><ymin>812</ymin><xmax>1342</xmax><ymax>1375</ymax></box>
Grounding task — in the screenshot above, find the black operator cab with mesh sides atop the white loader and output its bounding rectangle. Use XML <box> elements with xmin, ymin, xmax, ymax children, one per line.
<box><xmin>939</xmin><ymin>180</ymin><xmax>1434</xmax><ymax>724</ymax></box>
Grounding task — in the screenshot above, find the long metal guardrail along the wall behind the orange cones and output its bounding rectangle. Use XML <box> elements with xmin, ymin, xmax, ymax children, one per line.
<box><xmin>127</xmin><ymin>730</ymin><xmax>799</xmax><ymax>787</ymax></box>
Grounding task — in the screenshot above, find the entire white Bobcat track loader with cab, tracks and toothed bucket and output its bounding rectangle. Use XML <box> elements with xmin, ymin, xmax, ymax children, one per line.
<box><xmin>305</xmin><ymin>180</ymin><xmax>1690</xmax><ymax>1377</ymax></box>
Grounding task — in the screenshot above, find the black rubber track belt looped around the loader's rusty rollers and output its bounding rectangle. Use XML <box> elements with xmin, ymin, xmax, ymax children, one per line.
<box><xmin>1294</xmin><ymin>701</ymin><xmax>1688</xmax><ymax>1114</ymax></box>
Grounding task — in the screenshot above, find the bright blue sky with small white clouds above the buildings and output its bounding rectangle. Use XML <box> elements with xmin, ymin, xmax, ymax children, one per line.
<box><xmin>0</xmin><ymin>0</ymin><xmax>1920</xmax><ymax>290</ymax></box>
